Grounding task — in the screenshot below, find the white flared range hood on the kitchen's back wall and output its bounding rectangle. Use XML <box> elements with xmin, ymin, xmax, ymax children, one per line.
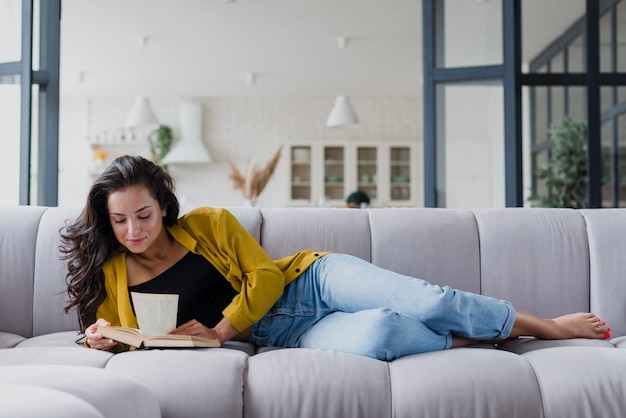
<box><xmin>163</xmin><ymin>102</ymin><xmax>211</xmax><ymax>164</ymax></box>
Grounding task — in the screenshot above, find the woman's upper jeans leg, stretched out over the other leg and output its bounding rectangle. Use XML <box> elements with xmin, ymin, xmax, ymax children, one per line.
<box><xmin>311</xmin><ymin>254</ymin><xmax>515</xmax><ymax>340</ymax></box>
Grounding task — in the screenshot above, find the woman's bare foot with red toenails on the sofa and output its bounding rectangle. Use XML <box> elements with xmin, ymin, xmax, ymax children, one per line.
<box><xmin>511</xmin><ymin>310</ymin><xmax>611</xmax><ymax>340</ymax></box>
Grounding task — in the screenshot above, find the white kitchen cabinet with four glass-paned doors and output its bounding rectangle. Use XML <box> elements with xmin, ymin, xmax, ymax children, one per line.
<box><xmin>290</xmin><ymin>141</ymin><xmax>417</xmax><ymax>207</ymax></box>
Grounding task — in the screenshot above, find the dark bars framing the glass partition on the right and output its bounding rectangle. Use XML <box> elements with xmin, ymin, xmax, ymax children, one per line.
<box><xmin>422</xmin><ymin>0</ymin><xmax>626</xmax><ymax>208</ymax></box>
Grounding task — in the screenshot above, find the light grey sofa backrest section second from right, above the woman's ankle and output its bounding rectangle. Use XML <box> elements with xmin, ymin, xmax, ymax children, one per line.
<box><xmin>475</xmin><ymin>208</ymin><xmax>589</xmax><ymax>318</ymax></box>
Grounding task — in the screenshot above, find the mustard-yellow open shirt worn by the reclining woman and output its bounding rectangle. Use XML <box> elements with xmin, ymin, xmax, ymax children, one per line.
<box><xmin>97</xmin><ymin>207</ymin><xmax>328</xmax><ymax>331</ymax></box>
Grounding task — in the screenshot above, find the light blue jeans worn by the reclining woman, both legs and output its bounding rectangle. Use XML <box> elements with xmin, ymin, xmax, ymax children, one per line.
<box><xmin>250</xmin><ymin>254</ymin><xmax>515</xmax><ymax>360</ymax></box>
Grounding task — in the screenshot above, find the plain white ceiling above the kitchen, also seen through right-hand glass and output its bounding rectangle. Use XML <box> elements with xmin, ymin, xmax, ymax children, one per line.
<box><xmin>61</xmin><ymin>0</ymin><xmax>585</xmax><ymax>98</ymax></box>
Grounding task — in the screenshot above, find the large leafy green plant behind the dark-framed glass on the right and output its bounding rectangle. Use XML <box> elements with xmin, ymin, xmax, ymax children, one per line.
<box><xmin>528</xmin><ymin>117</ymin><xmax>588</xmax><ymax>209</ymax></box>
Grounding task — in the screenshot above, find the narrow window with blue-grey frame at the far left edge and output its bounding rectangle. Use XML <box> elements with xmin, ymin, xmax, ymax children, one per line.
<box><xmin>0</xmin><ymin>0</ymin><xmax>61</xmax><ymax>206</ymax></box>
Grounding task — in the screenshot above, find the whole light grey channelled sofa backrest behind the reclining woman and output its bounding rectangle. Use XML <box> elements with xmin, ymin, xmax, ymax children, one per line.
<box><xmin>0</xmin><ymin>207</ymin><xmax>626</xmax><ymax>337</ymax></box>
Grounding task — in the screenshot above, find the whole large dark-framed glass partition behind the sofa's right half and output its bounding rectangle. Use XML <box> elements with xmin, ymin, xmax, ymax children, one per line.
<box><xmin>423</xmin><ymin>0</ymin><xmax>626</xmax><ymax>207</ymax></box>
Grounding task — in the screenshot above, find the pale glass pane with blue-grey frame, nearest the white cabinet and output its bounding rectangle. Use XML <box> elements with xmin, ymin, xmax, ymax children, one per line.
<box><xmin>422</xmin><ymin>0</ymin><xmax>521</xmax><ymax>207</ymax></box>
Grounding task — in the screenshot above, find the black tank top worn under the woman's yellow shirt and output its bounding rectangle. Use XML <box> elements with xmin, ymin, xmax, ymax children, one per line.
<box><xmin>128</xmin><ymin>251</ymin><xmax>237</xmax><ymax>328</ymax></box>
